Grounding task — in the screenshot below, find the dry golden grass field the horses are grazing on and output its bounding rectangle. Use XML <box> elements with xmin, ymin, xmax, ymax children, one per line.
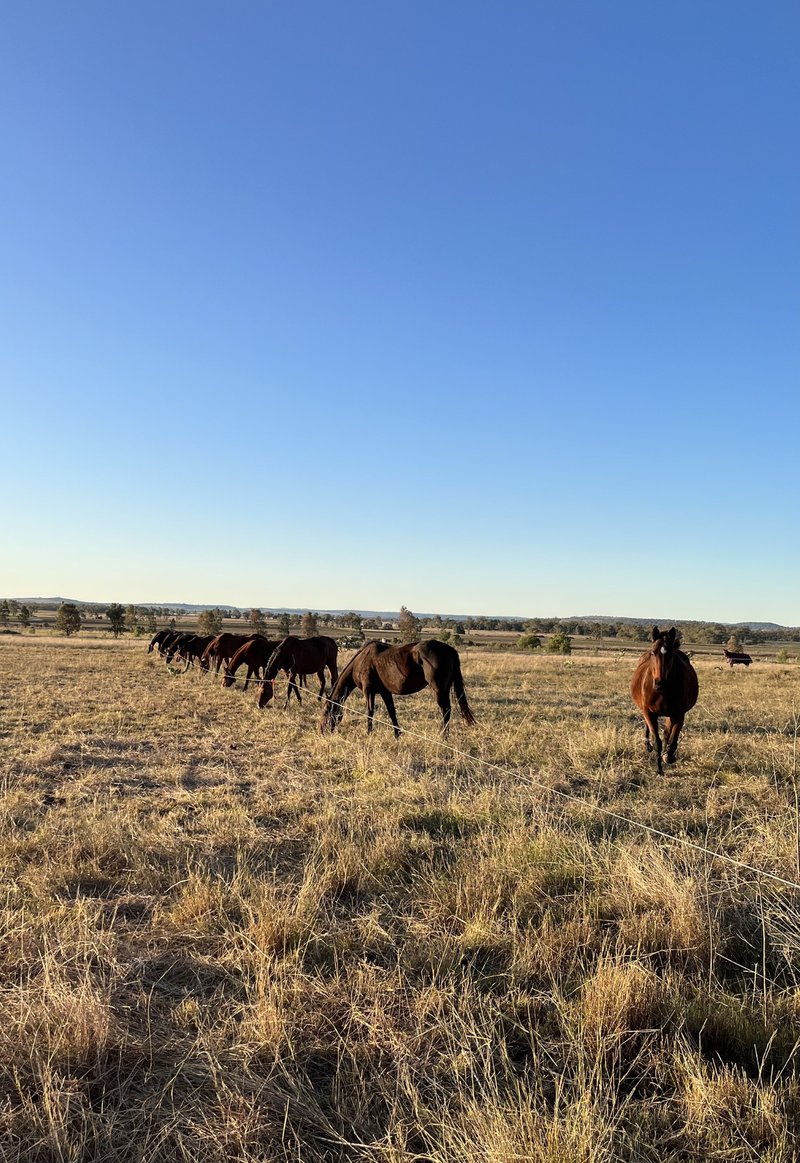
<box><xmin>0</xmin><ymin>636</ymin><xmax>800</xmax><ymax>1163</ymax></box>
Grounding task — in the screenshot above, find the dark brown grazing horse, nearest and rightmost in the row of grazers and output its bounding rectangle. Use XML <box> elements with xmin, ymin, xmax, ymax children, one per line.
<box><xmin>320</xmin><ymin>638</ymin><xmax>476</xmax><ymax>739</ymax></box>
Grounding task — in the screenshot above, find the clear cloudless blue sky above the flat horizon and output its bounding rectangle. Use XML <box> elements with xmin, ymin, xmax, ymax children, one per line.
<box><xmin>0</xmin><ymin>0</ymin><xmax>800</xmax><ymax>625</ymax></box>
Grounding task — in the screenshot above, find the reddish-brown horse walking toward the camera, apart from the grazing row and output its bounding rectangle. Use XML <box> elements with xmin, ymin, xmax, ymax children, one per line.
<box><xmin>630</xmin><ymin>626</ymin><xmax>698</xmax><ymax>775</ymax></box>
